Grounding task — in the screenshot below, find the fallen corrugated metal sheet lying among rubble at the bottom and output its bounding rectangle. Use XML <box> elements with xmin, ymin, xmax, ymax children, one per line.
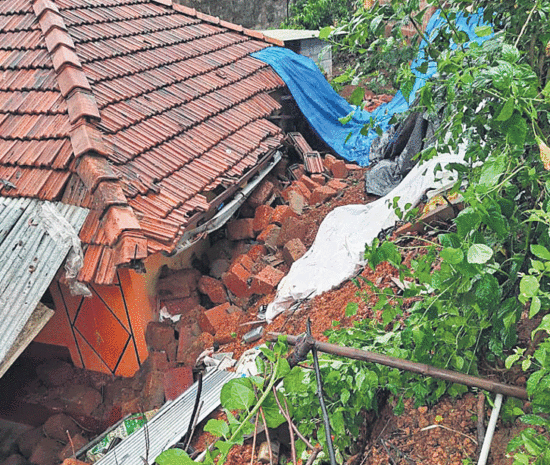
<box><xmin>96</xmin><ymin>371</ymin><xmax>239</xmax><ymax>465</ymax></box>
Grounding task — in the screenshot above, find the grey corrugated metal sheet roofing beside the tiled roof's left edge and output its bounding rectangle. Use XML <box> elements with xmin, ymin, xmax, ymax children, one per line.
<box><xmin>0</xmin><ymin>197</ymin><xmax>88</xmax><ymax>376</ymax></box>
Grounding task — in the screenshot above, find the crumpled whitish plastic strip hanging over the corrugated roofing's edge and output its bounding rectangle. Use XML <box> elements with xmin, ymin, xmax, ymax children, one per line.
<box><xmin>40</xmin><ymin>202</ymin><xmax>92</xmax><ymax>297</ymax></box>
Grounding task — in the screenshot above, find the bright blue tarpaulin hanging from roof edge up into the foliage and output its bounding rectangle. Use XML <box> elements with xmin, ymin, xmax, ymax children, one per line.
<box><xmin>252</xmin><ymin>11</ymin><xmax>490</xmax><ymax>166</ymax></box>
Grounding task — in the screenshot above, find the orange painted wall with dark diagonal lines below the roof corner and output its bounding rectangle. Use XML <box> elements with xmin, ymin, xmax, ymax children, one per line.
<box><xmin>35</xmin><ymin>269</ymin><xmax>153</xmax><ymax>376</ymax></box>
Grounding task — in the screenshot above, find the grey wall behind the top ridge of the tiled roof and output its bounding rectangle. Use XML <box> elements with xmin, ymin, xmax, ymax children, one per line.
<box><xmin>176</xmin><ymin>0</ymin><xmax>287</xmax><ymax>29</ymax></box>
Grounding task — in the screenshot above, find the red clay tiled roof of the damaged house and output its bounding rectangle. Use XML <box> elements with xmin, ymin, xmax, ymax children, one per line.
<box><xmin>0</xmin><ymin>0</ymin><xmax>284</xmax><ymax>284</ymax></box>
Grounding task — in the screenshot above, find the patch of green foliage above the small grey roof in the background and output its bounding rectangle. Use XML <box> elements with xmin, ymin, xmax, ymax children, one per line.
<box><xmin>281</xmin><ymin>0</ymin><xmax>357</xmax><ymax>30</ymax></box>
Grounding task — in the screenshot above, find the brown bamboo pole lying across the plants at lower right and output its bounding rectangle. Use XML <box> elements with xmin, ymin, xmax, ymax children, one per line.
<box><xmin>267</xmin><ymin>332</ymin><xmax>528</xmax><ymax>400</ymax></box>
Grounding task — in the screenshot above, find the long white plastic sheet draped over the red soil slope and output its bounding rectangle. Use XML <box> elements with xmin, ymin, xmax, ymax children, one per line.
<box><xmin>266</xmin><ymin>153</ymin><xmax>464</xmax><ymax>322</ymax></box>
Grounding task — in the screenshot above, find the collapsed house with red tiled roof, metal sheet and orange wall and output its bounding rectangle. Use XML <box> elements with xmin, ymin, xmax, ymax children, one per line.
<box><xmin>0</xmin><ymin>0</ymin><xmax>302</xmax><ymax>376</ymax></box>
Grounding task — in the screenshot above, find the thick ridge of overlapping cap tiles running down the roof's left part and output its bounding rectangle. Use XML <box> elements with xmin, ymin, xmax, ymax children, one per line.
<box><xmin>33</xmin><ymin>0</ymin><xmax>151</xmax><ymax>278</ymax></box>
